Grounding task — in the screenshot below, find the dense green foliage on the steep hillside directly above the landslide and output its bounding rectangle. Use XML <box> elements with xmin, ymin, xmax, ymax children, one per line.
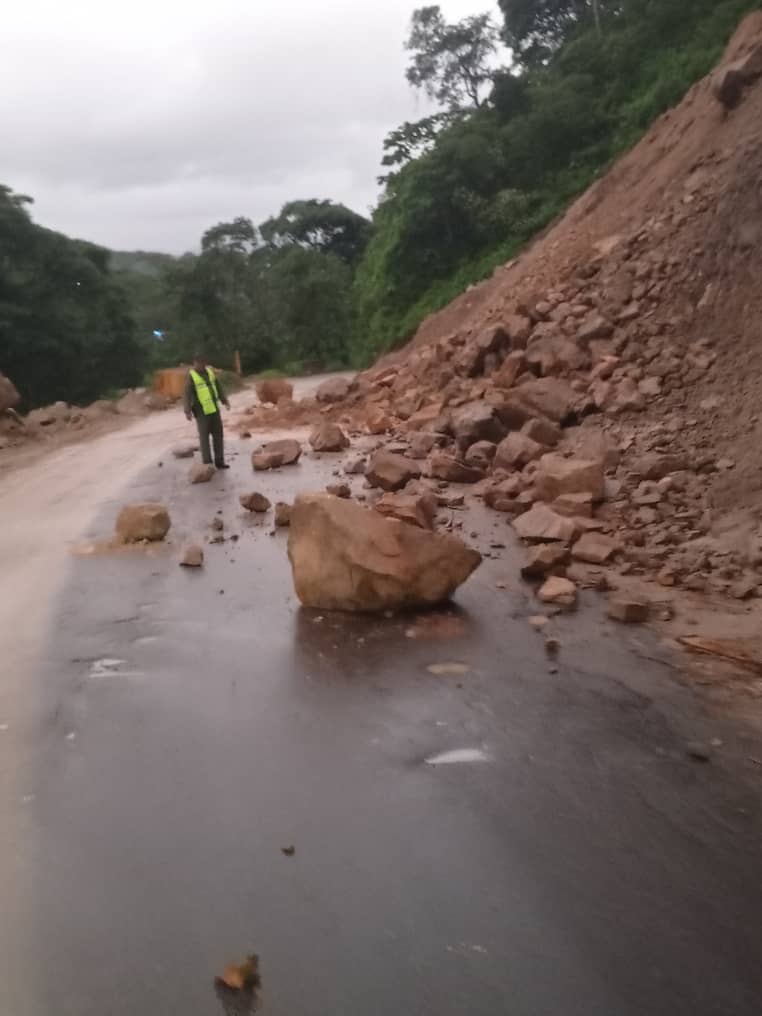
<box><xmin>354</xmin><ymin>0</ymin><xmax>759</xmax><ymax>362</ymax></box>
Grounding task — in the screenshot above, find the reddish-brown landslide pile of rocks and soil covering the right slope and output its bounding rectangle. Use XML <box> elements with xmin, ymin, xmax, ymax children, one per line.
<box><xmin>273</xmin><ymin>12</ymin><xmax>762</xmax><ymax>602</ymax></box>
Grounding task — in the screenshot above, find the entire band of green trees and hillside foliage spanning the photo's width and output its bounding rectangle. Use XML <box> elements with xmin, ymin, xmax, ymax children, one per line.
<box><xmin>0</xmin><ymin>0</ymin><xmax>759</xmax><ymax>404</ymax></box>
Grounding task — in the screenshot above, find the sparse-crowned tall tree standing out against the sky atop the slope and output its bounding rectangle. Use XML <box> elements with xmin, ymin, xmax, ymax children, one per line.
<box><xmin>405</xmin><ymin>5</ymin><xmax>500</xmax><ymax>110</ymax></box>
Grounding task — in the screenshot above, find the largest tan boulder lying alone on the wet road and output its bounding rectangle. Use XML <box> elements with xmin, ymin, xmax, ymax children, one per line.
<box><xmin>289</xmin><ymin>494</ymin><xmax>482</xmax><ymax>612</ymax></box>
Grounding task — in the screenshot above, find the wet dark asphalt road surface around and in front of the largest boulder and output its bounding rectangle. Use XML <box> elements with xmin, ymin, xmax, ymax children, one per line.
<box><xmin>0</xmin><ymin>442</ymin><xmax>762</xmax><ymax>1016</ymax></box>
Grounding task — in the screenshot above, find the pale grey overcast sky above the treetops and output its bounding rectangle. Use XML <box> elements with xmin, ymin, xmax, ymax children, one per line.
<box><xmin>0</xmin><ymin>0</ymin><xmax>497</xmax><ymax>253</ymax></box>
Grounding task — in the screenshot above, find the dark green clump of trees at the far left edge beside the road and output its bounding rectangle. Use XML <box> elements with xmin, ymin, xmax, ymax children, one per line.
<box><xmin>0</xmin><ymin>186</ymin><xmax>144</xmax><ymax>406</ymax></box>
